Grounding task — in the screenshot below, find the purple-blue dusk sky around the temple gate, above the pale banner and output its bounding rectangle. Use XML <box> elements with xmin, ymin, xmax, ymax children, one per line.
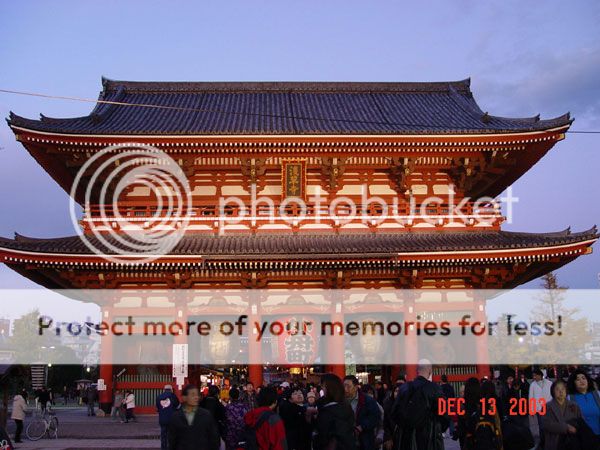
<box><xmin>0</xmin><ymin>0</ymin><xmax>600</xmax><ymax>288</ymax></box>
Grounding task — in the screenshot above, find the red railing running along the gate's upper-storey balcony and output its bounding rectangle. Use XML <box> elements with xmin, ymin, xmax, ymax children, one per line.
<box><xmin>81</xmin><ymin>202</ymin><xmax>504</xmax><ymax>231</ymax></box>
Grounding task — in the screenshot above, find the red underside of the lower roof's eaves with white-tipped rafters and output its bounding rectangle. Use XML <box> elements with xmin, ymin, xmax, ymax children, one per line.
<box><xmin>0</xmin><ymin>239</ymin><xmax>596</xmax><ymax>289</ymax></box>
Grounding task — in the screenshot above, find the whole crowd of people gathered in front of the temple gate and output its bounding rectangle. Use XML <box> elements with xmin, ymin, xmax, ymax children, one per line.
<box><xmin>4</xmin><ymin>360</ymin><xmax>600</xmax><ymax>450</ymax></box>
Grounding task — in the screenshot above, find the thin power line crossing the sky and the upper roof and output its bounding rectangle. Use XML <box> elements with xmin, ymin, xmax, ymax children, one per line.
<box><xmin>0</xmin><ymin>89</ymin><xmax>600</xmax><ymax>134</ymax></box>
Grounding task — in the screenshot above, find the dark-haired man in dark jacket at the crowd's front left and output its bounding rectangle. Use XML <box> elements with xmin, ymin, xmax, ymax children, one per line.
<box><xmin>168</xmin><ymin>384</ymin><xmax>221</xmax><ymax>450</ymax></box>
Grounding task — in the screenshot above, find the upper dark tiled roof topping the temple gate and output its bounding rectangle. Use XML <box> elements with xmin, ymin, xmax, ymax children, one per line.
<box><xmin>7</xmin><ymin>79</ymin><xmax>571</xmax><ymax>135</ymax></box>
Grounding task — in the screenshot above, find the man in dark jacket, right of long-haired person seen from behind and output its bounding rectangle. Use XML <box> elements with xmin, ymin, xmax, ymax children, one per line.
<box><xmin>344</xmin><ymin>375</ymin><xmax>381</xmax><ymax>450</ymax></box>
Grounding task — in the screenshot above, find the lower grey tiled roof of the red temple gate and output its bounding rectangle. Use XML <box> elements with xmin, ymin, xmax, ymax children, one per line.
<box><xmin>0</xmin><ymin>227</ymin><xmax>598</xmax><ymax>259</ymax></box>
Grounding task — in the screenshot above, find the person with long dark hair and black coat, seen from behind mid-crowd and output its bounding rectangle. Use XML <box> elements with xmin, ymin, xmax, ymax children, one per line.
<box><xmin>313</xmin><ymin>373</ymin><xmax>357</xmax><ymax>450</ymax></box>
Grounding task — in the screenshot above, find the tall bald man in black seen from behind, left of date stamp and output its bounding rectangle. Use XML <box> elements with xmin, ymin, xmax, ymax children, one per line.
<box><xmin>392</xmin><ymin>359</ymin><xmax>448</xmax><ymax>450</ymax></box>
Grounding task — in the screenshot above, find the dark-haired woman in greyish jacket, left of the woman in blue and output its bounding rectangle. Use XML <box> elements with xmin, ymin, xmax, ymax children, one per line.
<box><xmin>542</xmin><ymin>378</ymin><xmax>581</xmax><ymax>450</ymax></box>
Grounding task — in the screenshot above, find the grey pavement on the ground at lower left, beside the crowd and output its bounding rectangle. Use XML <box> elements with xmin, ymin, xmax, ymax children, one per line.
<box><xmin>2</xmin><ymin>407</ymin><xmax>459</xmax><ymax>450</ymax></box>
